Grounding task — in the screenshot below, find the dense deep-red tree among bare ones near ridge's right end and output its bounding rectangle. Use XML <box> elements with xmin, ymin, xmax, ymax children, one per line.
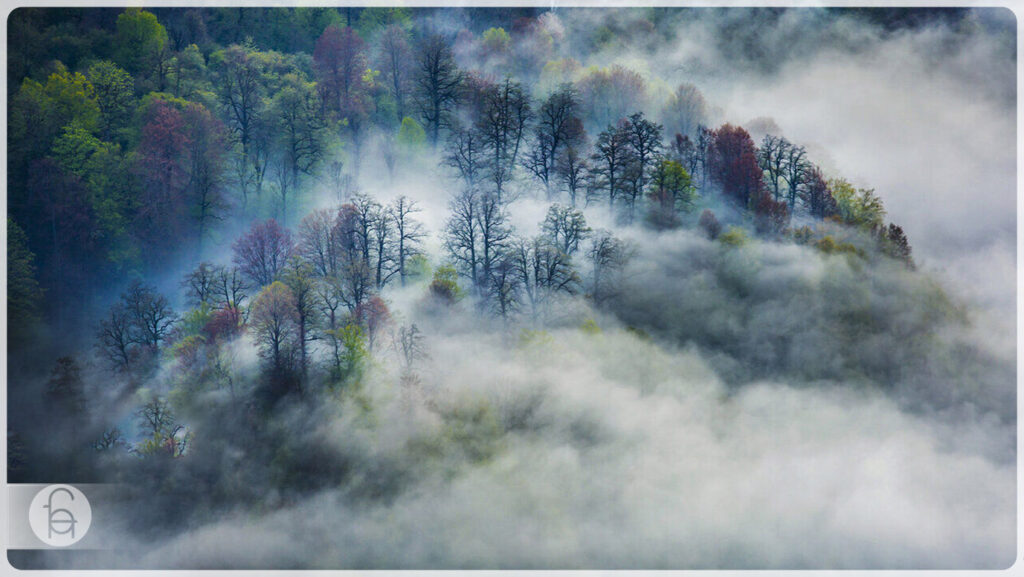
<box><xmin>708</xmin><ymin>124</ymin><xmax>763</xmax><ymax>208</ymax></box>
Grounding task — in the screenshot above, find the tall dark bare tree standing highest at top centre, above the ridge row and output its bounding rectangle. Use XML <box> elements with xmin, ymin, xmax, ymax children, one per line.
<box><xmin>414</xmin><ymin>34</ymin><xmax>463</xmax><ymax>148</ymax></box>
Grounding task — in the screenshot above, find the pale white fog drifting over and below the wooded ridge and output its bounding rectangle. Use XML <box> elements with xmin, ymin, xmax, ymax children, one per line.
<box><xmin>14</xmin><ymin>5</ymin><xmax>1017</xmax><ymax>569</ymax></box>
